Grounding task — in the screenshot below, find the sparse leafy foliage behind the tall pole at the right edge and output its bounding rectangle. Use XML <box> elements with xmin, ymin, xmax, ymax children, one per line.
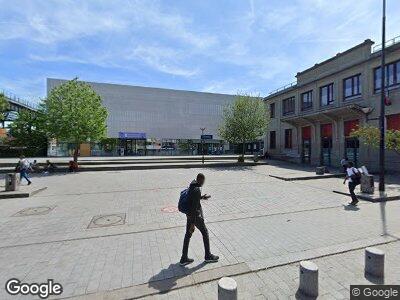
<box><xmin>351</xmin><ymin>125</ymin><xmax>400</xmax><ymax>154</ymax></box>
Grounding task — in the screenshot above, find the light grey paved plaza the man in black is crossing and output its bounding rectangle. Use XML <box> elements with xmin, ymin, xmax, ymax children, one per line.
<box><xmin>0</xmin><ymin>165</ymin><xmax>400</xmax><ymax>299</ymax></box>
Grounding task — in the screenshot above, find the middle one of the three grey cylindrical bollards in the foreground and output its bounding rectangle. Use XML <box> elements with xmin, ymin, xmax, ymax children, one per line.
<box><xmin>299</xmin><ymin>261</ymin><xmax>318</xmax><ymax>297</ymax></box>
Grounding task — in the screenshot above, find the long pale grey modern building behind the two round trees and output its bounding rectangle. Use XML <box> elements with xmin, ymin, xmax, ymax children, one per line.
<box><xmin>47</xmin><ymin>78</ymin><xmax>259</xmax><ymax>155</ymax></box>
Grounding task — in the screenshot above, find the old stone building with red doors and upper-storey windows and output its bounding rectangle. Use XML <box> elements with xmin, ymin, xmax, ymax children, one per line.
<box><xmin>265</xmin><ymin>40</ymin><xmax>400</xmax><ymax>170</ymax></box>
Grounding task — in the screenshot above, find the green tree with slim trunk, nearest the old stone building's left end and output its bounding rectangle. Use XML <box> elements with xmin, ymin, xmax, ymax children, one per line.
<box><xmin>219</xmin><ymin>94</ymin><xmax>269</xmax><ymax>161</ymax></box>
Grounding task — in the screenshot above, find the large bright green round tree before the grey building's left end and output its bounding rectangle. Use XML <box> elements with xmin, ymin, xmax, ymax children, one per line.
<box><xmin>41</xmin><ymin>78</ymin><xmax>107</xmax><ymax>162</ymax></box>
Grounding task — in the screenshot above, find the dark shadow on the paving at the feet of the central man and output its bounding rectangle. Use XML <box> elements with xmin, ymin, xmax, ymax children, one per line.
<box><xmin>148</xmin><ymin>262</ymin><xmax>206</xmax><ymax>294</ymax></box>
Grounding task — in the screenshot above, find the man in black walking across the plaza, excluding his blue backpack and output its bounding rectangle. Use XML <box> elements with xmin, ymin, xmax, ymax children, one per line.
<box><xmin>180</xmin><ymin>173</ymin><xmax>219</xmax><ymax>266</ymax></box>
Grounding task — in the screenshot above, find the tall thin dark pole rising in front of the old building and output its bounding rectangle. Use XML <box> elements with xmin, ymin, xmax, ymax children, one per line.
<box><xmin>379</xmin><ymin>0</ymin><xmax>386</xmax><ymax>192</ymax></box>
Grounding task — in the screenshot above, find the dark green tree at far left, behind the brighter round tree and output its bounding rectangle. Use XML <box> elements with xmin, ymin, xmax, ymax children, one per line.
<box><xmin>10</xmin><ymin>109</ymin><xmax>47</xmax><ymax>156</ymax></box>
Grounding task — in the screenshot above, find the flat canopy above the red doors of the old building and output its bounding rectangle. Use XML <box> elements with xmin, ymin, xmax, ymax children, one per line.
<box><xmin>281</xmin><ymin>104</ymin><xmax>371</xmax><ymax>126</ymax></box>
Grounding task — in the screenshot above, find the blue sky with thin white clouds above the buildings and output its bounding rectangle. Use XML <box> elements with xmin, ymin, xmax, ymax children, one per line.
<box><xmin>0</xmin><ymin>0</ymin><xmax>400</xmax><ymax>101</ymax></box>
